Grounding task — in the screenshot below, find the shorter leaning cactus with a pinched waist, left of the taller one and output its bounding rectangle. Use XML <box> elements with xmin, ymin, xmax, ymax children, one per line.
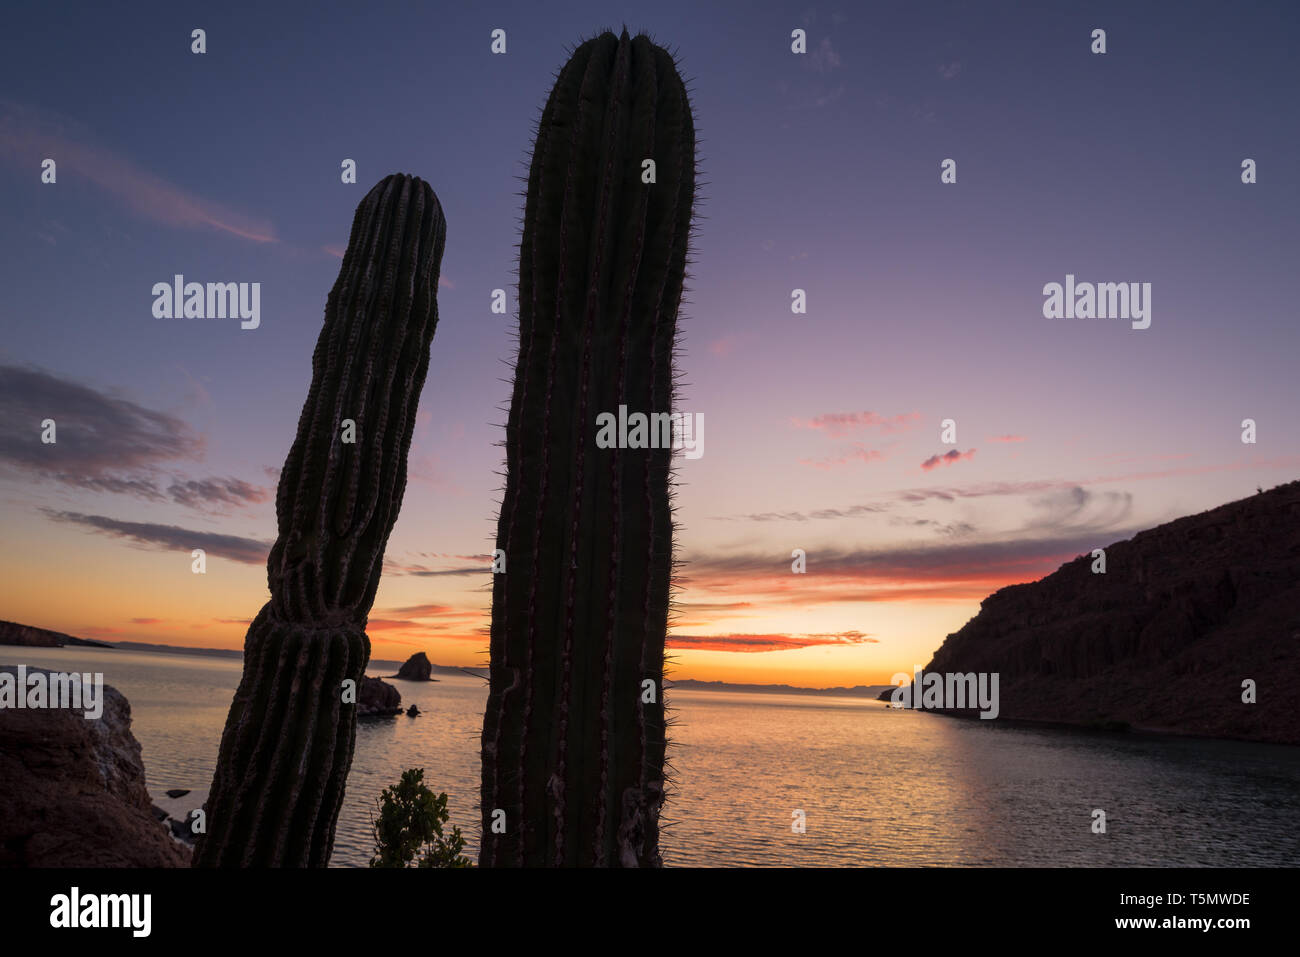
<box><xmin>194</xmin><ymin>174</ymin><xmax>446</xmax><ymax>867</ymax></box>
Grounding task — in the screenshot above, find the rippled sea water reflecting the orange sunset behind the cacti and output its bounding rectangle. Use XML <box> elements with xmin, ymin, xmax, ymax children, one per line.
<box><xmin>0</xmin><ymin>646</ymin><xmax>1300</xmax><ymax>867</ymax></box>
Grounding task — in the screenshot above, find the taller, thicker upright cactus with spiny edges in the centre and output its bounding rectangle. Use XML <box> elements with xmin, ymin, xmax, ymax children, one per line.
<box><xmin>480</xmin><ymin>30</ymin><xmax>696</xmax><ymax>866</ymax></box>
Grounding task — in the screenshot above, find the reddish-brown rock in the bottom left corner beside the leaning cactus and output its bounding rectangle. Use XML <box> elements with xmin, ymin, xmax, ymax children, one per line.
<box><xmin>0</xmin><ymin>666</ymin><xmax>190</xmax><ymax>867</ymax></box>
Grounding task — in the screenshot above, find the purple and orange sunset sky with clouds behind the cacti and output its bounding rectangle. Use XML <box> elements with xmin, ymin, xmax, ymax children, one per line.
<box><xmin>0</xmin><ymin>0</ymin><xmax>1300</xmax><ymax>687</ymax></box>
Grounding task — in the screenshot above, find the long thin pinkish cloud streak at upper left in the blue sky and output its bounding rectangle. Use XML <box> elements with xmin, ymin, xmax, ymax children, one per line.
<box><xmin>0</xmin><ymin>100</ymin><xmax>276</xmax><ymax>243</ymax></box>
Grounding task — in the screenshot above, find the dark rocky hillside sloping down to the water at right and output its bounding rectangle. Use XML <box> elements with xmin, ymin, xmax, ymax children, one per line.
<box><xmin>926</xmin><ymin>481</ymin><xmax>1300</xmax><ymax>744</ymax></box>
